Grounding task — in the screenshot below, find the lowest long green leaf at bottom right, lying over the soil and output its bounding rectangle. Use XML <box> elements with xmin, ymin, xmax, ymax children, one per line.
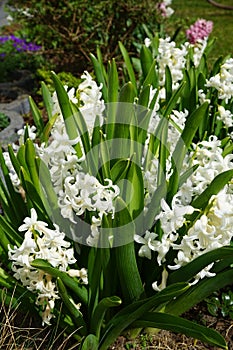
<box><xmin>131</xmin><ymin>312</ymin><xmax>227</xmax><ymax>349</ymax></box>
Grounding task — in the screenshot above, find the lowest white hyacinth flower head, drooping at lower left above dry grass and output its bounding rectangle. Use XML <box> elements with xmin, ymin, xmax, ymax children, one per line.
<box><xmin>8</xmin><ymin>208</ymin><xmax>87</xmax><ymax>325</ymax></box>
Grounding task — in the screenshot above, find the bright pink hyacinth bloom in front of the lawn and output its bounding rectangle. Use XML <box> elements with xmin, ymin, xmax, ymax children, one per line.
<box><xmin>186</xmin><ymin>19</ymin><xmax>213</xmax><ymax>44</ymax></box>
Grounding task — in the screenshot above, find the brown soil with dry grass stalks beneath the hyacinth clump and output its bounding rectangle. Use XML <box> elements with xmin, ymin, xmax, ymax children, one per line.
<box><xmin>0</xmin><ymin>302</ymin><xmax>233</xmax><ymax>350</ymax></box>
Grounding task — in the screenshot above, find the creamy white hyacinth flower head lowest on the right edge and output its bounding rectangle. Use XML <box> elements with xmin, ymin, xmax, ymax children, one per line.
<box><xmin>169</xmin><ymin>186</ymin><xmax>233</xmax><ymax>283</ymax></box>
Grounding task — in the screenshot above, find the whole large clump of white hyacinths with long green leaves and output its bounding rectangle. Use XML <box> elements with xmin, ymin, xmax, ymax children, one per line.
<box><xmin>0</xmin><ymin>25</ymin><xmax>233</xmax><ymax>350</ymax></box>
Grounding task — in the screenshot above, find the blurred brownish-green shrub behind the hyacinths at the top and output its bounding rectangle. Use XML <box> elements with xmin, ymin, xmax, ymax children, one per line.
<box><xmin>5</xmin><ymin>0</ymin><xmax>162</xmax><ymax>74</ymax></box>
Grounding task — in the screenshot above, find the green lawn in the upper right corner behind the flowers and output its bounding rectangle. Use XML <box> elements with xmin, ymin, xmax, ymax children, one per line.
<box><xmin>167</xmin><ymin>0</ymin><xmax>233</xmax><ymax>61</ymax></box>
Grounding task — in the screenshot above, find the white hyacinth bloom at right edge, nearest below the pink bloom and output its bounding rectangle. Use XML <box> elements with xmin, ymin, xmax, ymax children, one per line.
<box><xmin>206</xmin><ymin>58</ymin><xmax>233</xmax><ymax>103</ymax></box>
